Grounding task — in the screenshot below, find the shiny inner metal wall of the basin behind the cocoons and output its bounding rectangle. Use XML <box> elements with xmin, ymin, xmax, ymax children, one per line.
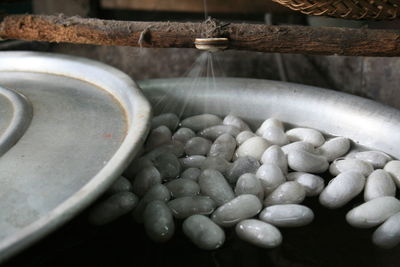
<box><xmin>139</xmin><ymin>78</ymin><xmax>400</xmax><ymax>158</ymax></box>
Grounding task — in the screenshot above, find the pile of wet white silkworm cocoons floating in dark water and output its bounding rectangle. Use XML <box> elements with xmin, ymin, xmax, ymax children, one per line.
<box><xmin>89</xmin><ymin>113</ymin><xmax>400</xmax><ymax>250</ymax></box>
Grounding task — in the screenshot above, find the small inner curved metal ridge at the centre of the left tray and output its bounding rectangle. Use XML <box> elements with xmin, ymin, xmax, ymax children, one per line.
<box><xmin>0</xmin><ymin>86</ymin><xmax>33</xmax><ymax>157</ymax></box>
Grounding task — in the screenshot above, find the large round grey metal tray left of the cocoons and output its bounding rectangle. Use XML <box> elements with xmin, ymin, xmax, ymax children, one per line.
<box><xmin>0</xmin><ymin>52</ymin><xmax>151</xmax><ymax>262</ymax></box>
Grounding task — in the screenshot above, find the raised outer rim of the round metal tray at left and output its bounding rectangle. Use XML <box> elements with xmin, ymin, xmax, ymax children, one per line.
<box><xmin>0</xmin><ymin>51</ymin><xmax>152</xmax><ymax>263</ymax></box>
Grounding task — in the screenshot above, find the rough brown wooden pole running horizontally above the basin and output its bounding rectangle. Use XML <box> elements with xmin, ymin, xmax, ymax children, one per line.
<box><xmin>0</xmin><ymin>15</ymin><xmax>400</xmax><ymax>56</ymax></box>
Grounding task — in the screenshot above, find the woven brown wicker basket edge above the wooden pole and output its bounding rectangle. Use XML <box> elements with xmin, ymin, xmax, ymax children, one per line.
<box><xmin>273</xmin><ymin>0</ymin><xmax>400</xmax><ymax>20</ymax></box>
